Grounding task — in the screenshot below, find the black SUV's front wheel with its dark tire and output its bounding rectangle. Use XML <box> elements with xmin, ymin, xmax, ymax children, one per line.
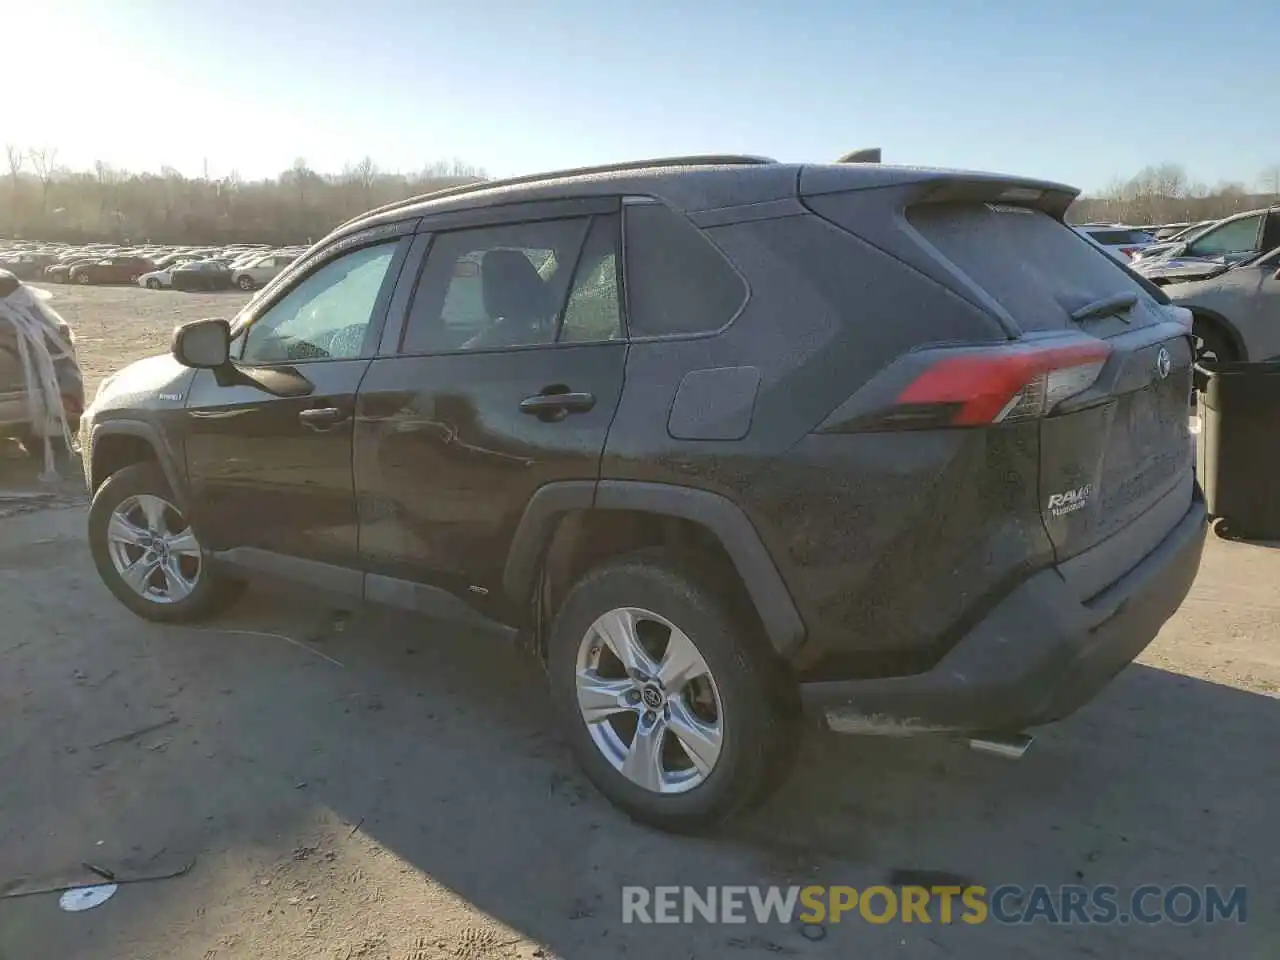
<box><xmin>88</xmin><ymin>462</ymin><xmax>243</xmax><ymax>623</ymax></box>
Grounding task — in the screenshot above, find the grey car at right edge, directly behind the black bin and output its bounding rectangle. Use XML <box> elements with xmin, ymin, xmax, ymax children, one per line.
<box><xmin>1165</xmin><ymin>250</ymin><xmax>1280</xmax><ymax>362</ymax></box>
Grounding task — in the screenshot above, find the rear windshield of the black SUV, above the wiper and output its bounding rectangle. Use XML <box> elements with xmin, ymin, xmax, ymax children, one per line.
<box><xmin>908</xmin><ymin>204</ymin><xmax>1144</xmax><ymax>333</ymax></box>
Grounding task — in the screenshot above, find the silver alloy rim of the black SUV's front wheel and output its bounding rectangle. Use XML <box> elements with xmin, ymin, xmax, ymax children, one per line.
<box><xmin>106</xmin><ymin>494</ymin><xmax>204</xmax><ymax>603</ymax></box>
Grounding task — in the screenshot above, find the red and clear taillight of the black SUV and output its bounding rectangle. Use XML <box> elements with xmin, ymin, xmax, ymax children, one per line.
<box><xmin>879</xmin><ymin>342</ymin><xmax>1111</xmax><ymax>429</ymax></box>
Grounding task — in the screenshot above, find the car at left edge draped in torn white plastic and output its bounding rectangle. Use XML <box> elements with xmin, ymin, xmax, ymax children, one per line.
<box><xmin>0</xmin><ymin>270</ymin><xmax>84</xmax><ymax>456</ymax></box>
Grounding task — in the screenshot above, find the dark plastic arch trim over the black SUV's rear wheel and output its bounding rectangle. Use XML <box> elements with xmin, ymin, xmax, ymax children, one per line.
<box><xmin>503</xmin><ymin>480</ymin><xmax>805</xmax><ymax>655</ymax></box>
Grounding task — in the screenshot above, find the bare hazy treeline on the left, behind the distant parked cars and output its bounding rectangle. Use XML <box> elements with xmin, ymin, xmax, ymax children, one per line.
<box><xmin>0</xmin><ymin>145</ymin><xmax>485</xmax><ymax>244</ymax></box>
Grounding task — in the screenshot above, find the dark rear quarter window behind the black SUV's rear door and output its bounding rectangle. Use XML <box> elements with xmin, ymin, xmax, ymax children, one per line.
<box><xmin>625</xmin><ymin>204</ymin><xmax>746</xmax><ymax>337</ymax></box>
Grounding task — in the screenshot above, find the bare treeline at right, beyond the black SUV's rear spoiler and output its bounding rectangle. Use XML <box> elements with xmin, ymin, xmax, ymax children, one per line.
<box><xmin>1068</xmin><ymin>164</ymin><xmax>1280</xmax><ymax>224</ymax></box>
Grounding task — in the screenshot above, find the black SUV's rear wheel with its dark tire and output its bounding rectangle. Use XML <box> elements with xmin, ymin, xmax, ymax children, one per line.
<box><xmin>548</xmin><ymin>548</ymin><xmax>799</xmax><ymax>832</ymax></box>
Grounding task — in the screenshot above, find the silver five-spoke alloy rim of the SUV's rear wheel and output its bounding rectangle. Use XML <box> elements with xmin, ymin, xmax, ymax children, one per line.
<box><xmin>576</xmin><ymin>607</ymin><xmax>724</xmax><ymax>794</ymax></box>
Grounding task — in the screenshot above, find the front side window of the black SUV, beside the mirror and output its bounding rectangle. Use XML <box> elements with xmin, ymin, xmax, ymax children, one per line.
<box><xmin>240</xmin><ymin>243</ymin><xmax>397</xmax><ymax>364</ymax></box>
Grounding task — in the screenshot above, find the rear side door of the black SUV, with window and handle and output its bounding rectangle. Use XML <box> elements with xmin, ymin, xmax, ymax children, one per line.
<box><xmin>355</xmin><ymin>198</ymin><xmax>627</xmax><ymax>618</ymax></box>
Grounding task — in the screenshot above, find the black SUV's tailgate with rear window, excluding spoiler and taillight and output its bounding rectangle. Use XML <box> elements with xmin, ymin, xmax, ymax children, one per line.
<box><xmin>909</xmin><ymin>204</ymin><xmax>1194</xmax><ymax>578</ymax></box>
